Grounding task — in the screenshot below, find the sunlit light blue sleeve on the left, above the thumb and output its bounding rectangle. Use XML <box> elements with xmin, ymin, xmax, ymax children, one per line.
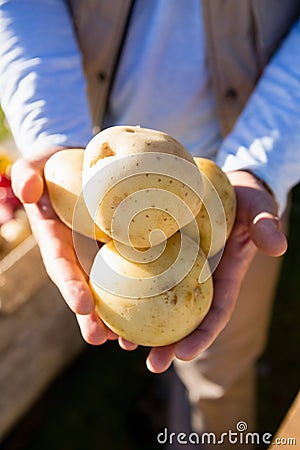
<box><xmin>0</xmin><ymin>0</ymin><xmax>92</xmax><ymax>156</ymax></box>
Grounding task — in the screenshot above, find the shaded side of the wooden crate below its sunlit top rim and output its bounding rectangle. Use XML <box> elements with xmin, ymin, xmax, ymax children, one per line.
<box><xmin>0</xmin><ymin>281</ymin><xmax>85</xmax><ymax>440</ymax></box>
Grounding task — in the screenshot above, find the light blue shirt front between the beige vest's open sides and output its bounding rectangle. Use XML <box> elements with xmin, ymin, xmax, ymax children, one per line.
<box><xmin>106</xmin><ymin>0</ymin><xmax>221</xmax><ymax>158</ymax></box>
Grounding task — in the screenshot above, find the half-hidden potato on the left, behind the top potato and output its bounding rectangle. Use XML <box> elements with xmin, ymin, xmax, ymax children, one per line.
<box><xmin>44</xmin><ymin>149</ymin><xmax>110</xmax><ymax>242</ymax></box>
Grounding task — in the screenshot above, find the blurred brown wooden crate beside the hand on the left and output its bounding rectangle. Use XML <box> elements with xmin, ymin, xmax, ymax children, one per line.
<box><xmin>0</xmin><ymin>236</ymin><xmax>85</xmax><ymax>441</ymax></box>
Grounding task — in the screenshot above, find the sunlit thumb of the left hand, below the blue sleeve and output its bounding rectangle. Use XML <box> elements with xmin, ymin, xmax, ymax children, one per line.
<box><xmin>11</xmin><ymin>159</ymin><xmax>44</xmax><ymax>203</ymax></box>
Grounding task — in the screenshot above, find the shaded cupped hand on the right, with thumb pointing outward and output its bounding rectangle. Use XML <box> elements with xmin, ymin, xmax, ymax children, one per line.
<box><xmin>147</xmin><ymin>171</ymin><xmax>287</xmax><ymax>373</ymax></box>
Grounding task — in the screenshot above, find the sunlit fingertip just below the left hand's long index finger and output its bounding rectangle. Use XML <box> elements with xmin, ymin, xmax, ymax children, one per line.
<box><xmin>76</xmin><ymin>311</ymin><xmax>108</xmax><ymax>345</ymax></box>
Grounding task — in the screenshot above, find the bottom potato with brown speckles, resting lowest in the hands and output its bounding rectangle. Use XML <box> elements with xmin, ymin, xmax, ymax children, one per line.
<box><xmin>90</xmin><ymin>232</ymin><xmax>213</xmax><ymax>347</ymax></box>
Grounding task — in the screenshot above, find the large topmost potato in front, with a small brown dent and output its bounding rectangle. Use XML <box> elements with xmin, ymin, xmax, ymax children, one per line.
<box><xmin>83</xmin><ymin>126</ymin><xmax>203</xmax><ymax>248</ymax></box>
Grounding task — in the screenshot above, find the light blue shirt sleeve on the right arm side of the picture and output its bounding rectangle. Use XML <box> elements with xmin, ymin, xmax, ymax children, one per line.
<box><xmin>217</xmin><ymin>21</ymin><xmax>300</xmax><ymax>214</ymax></box>
